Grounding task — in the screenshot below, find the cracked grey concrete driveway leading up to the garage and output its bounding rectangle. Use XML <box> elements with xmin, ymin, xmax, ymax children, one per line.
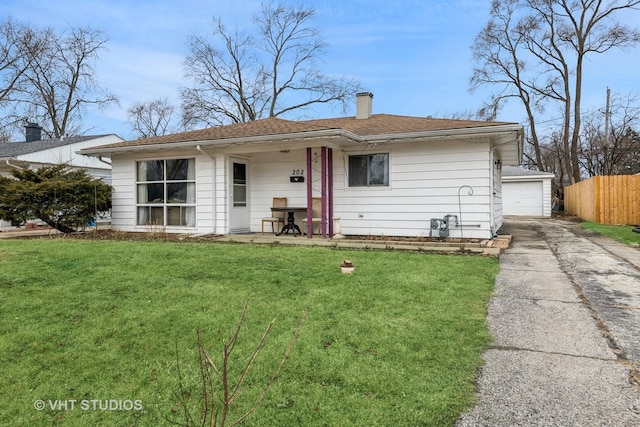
<box><xmin>456</xmin><ymin>219</ymin><xmax>640</xmax><ymax>427</ymax></box>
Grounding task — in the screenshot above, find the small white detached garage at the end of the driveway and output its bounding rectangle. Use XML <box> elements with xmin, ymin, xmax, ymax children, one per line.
<box><xmin>502</xmin><ymin>166</ymin><xmax>554</xmax><ymax>217</ymax></box>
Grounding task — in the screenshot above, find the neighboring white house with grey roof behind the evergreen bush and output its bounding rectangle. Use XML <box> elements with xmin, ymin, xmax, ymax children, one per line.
<box><xmin>0</xmin><ymin>123</ymin><xmax>124</xmax><ymax>229</ymax></box>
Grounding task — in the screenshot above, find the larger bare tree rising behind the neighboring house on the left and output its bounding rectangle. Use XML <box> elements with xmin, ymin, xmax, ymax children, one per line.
<box><xmin>20</xmin><ymin>28</ymin><xmax>118</xmax><ymax>138</ymax></box>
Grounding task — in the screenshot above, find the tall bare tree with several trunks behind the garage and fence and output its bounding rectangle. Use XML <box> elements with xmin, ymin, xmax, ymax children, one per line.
<box><xmin>471</xmin><ymin>0</ymin><xmax>640</xmax><ymax>182</ymax></box>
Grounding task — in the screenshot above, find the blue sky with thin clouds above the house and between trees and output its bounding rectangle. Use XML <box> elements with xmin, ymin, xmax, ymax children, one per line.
<box><xmin>0</xmin><ymin>0</ymin><xmax>640</xmax><ymax>139</ymax></box>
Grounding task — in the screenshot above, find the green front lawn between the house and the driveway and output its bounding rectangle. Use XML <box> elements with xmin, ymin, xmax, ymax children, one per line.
<box><xmin>0</xmin><ymin>239</ymin><xmax>498</xmax><ymax>426</ymax></box>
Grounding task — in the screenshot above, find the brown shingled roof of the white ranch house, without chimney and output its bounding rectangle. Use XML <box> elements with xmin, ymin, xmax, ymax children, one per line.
<box><xmin>84</xmin><ymin>114</ymin><xmax>516</xmax><ymax>151</ymax></box>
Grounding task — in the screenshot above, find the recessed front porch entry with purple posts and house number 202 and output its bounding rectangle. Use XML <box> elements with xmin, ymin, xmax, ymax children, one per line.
<box><xmin>231</xmin><ymin>145</ymin><xmax>344</xmax><ymax>239</ymax></box>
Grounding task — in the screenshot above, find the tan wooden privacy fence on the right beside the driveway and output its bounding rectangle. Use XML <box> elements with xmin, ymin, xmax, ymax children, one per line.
<box><xmin>564</xmin><ymin>175</ymin><xmax>640</xmax><ymax>225</ymax></box>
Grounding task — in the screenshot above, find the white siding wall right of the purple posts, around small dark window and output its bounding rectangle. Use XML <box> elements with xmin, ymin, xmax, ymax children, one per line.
<box><xmin>334</xmin><ymin>141</ymin><xmax>492</xmax><ymax>238</ymax></box>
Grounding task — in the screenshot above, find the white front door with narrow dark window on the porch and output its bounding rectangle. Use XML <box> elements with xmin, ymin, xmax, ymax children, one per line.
<box><xmin>229</xmin><ymin>158</ymin><xmax>249</xmax><ymax>233</ymax></box>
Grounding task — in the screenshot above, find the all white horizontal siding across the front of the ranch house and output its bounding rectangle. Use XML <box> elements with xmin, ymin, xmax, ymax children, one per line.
<box><xmin>112</xmin><ymin>141</ymin><xmax>502</xmax><ymax>238</ymax></box>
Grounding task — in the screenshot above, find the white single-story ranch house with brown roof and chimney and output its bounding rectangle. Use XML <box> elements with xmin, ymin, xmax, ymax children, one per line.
<box><xmin>81</xmin><ymin>93</ymin><xmax>523</xmax><ymax>238</ymax></box>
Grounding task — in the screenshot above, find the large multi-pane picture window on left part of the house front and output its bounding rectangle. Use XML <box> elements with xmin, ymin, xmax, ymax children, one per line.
<box><xmin>136</xmin><ymin>159</ymin><xmax>196</xmax><ymax>227</ymax></box>
